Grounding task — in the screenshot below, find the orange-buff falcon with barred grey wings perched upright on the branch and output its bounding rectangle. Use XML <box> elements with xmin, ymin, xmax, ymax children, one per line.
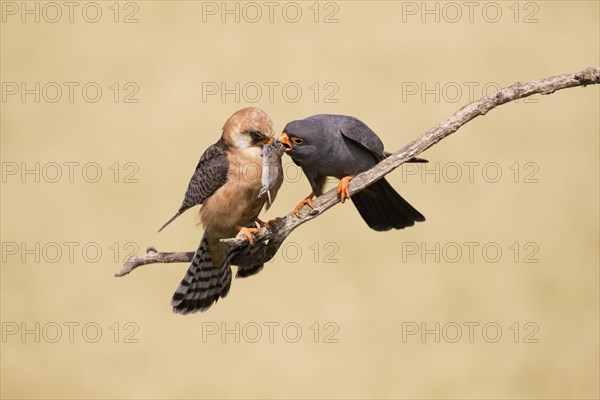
<box><xmin>159</xmin><ymin>107</ymin><xmax>282</xmax><ymax>314</ymax></box>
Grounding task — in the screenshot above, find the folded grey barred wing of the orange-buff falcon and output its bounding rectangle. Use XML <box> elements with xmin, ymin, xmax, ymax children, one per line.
<box><xmin>158</xmin><ymin>139</ymin><xmax>229</xmax><ymax>232</ymax></box>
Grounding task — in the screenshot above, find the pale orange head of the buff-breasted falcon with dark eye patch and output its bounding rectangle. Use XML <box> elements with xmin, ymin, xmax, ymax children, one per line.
<box><xmin>223</xmin><ymin>107</ymin><xmax>275</xmax><ymax>149</ymax></box>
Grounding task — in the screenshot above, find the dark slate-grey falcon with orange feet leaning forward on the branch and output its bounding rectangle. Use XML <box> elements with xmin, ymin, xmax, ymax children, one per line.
<box><xmin>277</xmin><ymin>114</ymin><xmax>426</xmax><ymax>231</ymax></box>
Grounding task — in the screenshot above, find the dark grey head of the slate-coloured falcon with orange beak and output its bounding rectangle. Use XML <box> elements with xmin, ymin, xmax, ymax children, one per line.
<box><xmin>277</xmin><ymin>120</ymin><xmax>328</xmax><ymax>163</ymax></box>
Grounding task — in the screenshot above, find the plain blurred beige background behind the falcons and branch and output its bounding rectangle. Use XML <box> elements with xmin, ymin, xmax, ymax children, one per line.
<box><xmin>0</xmin><ymin>1</ymin><xmax>600</xmax><ymax>399</ymax></box>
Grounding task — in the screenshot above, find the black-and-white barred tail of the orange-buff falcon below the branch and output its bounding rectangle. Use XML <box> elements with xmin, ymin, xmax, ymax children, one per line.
<box><xmin>171</xmin><ymin>236</ymin><xmax>235</xmax><ymax>314</ymax></box>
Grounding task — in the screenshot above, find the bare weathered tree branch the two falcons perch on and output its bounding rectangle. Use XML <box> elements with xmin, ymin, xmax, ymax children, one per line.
<box><xmin>115</xmin><ymin>67</ymin><xmax>600</xmax><ymax>276</ymax></box>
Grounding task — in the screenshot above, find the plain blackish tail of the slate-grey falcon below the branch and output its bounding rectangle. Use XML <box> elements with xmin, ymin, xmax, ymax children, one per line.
<box><xmin>351</xmin><ymin>179</ymin><xmax>425</xmax><ymax>231</ymax></box>
